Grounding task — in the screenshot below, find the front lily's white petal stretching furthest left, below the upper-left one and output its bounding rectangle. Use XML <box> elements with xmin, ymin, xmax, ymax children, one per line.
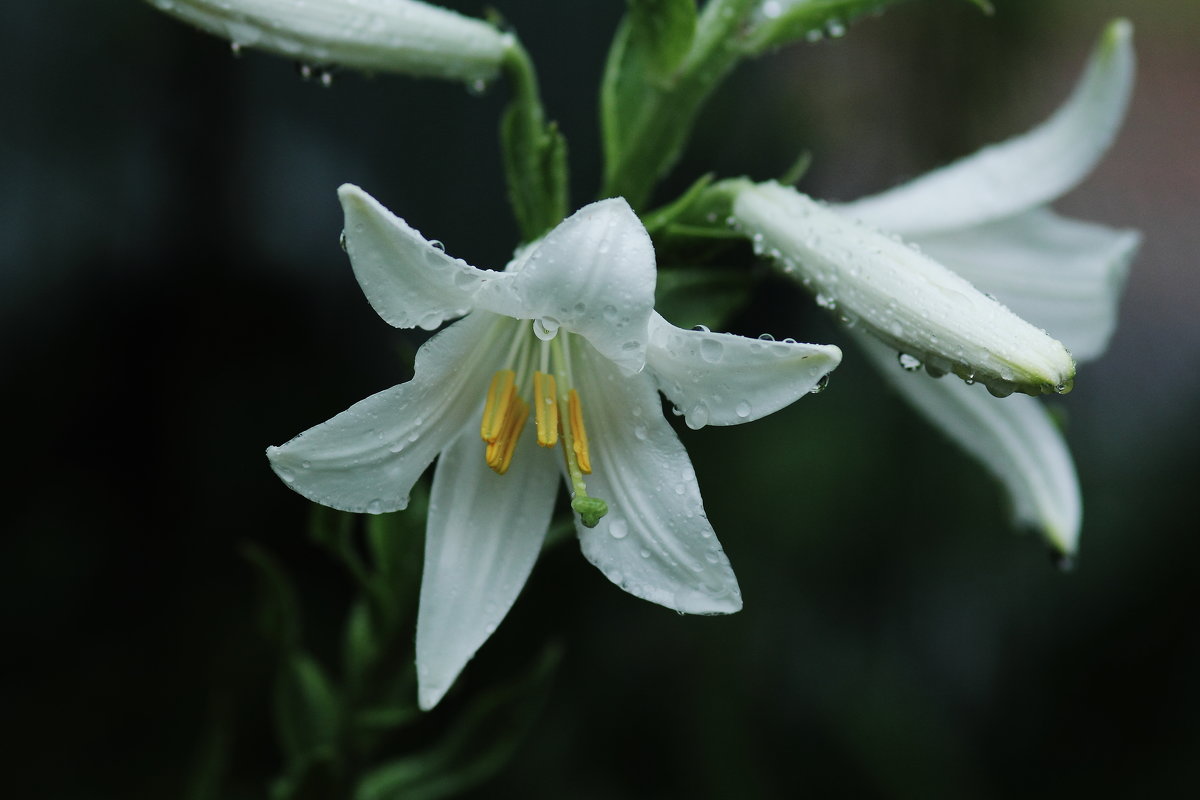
<box><xmin>266</xmin><ymin>313</ymin><xmax>512</xmax><ymax>513</ymax></box>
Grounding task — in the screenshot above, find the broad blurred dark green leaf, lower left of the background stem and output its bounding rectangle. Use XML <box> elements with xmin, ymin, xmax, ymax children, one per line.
<box><xmin>275</xmin><ymin>651</ymin><xmax>341</xmax><ymax>771</ymax></box>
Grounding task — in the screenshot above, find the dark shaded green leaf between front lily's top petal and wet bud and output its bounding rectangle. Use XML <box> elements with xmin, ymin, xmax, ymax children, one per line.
<box><xmin>654</xmin><ymin>267</ymin><xmax>752</xmax><ymax>330</ymax></box>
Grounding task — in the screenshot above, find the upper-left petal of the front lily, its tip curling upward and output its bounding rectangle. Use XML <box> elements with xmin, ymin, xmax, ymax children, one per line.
<box><xmin>337</xmin><ymin>184</ymin><xmax>500</xmax><ymax>331</ymax></box>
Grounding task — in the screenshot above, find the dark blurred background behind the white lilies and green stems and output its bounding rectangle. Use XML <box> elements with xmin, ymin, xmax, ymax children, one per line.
<box><xmin>0</xmin><ymin>0</ymin><xmax>1200</xmax><ymax>798</ymax></box>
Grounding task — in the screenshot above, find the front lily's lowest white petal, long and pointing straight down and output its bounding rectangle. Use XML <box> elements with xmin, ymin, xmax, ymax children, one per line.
<box><xmin>416</xmin><ymin>425</ymin><xmax>558</xmax><ymax>710</ymax></box>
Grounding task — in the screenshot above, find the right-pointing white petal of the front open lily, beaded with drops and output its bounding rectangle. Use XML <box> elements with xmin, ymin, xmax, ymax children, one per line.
<box><xmin>646</xmin><ymin>314</ymin><xmax>841</xmax><ymax>428</ymax></box>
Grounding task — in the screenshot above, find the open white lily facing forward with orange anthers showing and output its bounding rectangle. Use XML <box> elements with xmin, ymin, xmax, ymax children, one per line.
<box><xmin>268</xmin><ymin>185</ymin><xmax>841</xmax><ymax>709</ymax></box>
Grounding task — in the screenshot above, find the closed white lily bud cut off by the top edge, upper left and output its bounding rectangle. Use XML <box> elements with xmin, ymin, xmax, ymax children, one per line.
<box><xmin>149</xmin><ymin>0</ymin><xmax>512</xmax><ymax>83</ymax></box>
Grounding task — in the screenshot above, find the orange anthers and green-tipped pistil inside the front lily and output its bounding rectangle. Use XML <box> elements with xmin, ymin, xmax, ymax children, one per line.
<box><xmin>479</xmin><ymin>323</ymin><xmax>608</xmax><ymax>528</ymax></box>
